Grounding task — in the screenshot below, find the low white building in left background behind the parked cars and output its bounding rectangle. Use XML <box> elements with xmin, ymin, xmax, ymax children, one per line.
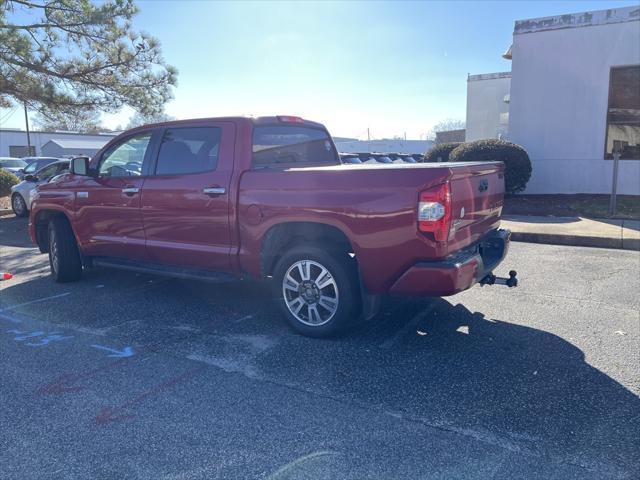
<box><xmin>0</xmin><ymin>128</ymin><xmax>116</xmax><ymax>157</ymax></box>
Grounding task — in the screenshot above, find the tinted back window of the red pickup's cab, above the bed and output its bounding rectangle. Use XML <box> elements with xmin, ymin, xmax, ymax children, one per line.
<box><xmin>253</xmin><ymin>125</ymin><xmax>340</xmax><ymax>167</ymax></box>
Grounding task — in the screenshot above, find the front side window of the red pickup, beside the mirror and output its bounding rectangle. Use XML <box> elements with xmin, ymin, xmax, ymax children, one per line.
<box><xmin>98</xmin><ymin>132</ymin><xmax>151</xmax><ymax>177</ymax></box>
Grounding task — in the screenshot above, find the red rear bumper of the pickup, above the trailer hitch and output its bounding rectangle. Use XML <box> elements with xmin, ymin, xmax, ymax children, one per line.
<box><xmin>389</xmin><ymin>230</ymin><xmax>511</xmax><ymax>297</ymax></box>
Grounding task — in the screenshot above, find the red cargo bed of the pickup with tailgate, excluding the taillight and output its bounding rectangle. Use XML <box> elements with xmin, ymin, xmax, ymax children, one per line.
<box><xmin>237</xmin><ymin>162</ymin><xmax>504</xmax><ymax>293</ymax></box>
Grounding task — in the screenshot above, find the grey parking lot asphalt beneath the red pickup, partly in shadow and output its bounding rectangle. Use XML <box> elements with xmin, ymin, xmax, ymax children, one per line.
<box><xmin>0</xmin><ymin>217</ymin><xmax>640</xmax><ymax>479</ymax></box>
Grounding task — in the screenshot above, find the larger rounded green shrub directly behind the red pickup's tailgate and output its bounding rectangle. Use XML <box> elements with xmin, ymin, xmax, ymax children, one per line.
<box><xmin>449</xmin><ymin>140</ymin><xmax>531</xmax><ymax>193</ymax></box>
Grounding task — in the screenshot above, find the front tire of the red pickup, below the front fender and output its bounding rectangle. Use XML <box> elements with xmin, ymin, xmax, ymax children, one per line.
<box><xmin>49</xmin><ymin>217</ymin><xmax>82</xmax><ymax>283</ymax></box>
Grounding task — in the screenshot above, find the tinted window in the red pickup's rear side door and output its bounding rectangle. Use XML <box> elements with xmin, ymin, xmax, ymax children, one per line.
<box><xmin>156</xmin><ymin>127</ymin><xmax>222</xmax><ymax>175</ymax></box>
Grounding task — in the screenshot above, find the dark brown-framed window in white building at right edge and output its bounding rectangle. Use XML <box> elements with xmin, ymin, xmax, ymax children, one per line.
<box><xmin>604</xmin><ymin>65</ymin><xmax>640</xmax><ymax>160</ymax></box>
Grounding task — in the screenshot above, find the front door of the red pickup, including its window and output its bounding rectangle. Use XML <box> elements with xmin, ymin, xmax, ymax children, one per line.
<box><xmin>75</xmin><ymin>130</ymin><xmax>157</xmax><ymax>260</ymax></box>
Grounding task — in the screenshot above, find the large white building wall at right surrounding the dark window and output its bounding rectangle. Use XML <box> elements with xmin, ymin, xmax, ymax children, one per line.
<box><xmin>510</xmin><ymin>13</ymin><xmax>640</xmax><ymax>195</ymax></box>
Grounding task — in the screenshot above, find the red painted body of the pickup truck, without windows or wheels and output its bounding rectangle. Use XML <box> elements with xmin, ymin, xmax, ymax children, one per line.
<box><xmin>29</xmin><ymin>117</ymin><xmax>508</xmax><ymax>295</ymax></box>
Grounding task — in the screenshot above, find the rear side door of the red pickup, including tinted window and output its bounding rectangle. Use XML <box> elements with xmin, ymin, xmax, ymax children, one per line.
<box><xmin>141</xmin><ymin>122</ymin><xmax>235</xmax><ymax>270</ymax></box>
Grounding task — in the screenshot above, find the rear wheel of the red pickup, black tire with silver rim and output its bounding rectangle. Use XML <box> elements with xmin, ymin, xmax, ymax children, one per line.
<box><xmin>273</xmin><ymin>245</ymin><xmax>361</xmax><ymax>338</ymax></box>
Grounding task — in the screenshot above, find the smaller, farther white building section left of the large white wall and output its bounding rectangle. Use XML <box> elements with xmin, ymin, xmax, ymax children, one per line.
<box><xmin>465</xmin><ymin>72</ymin><xmax>511</xmax><ymax>142</ymax></box>
